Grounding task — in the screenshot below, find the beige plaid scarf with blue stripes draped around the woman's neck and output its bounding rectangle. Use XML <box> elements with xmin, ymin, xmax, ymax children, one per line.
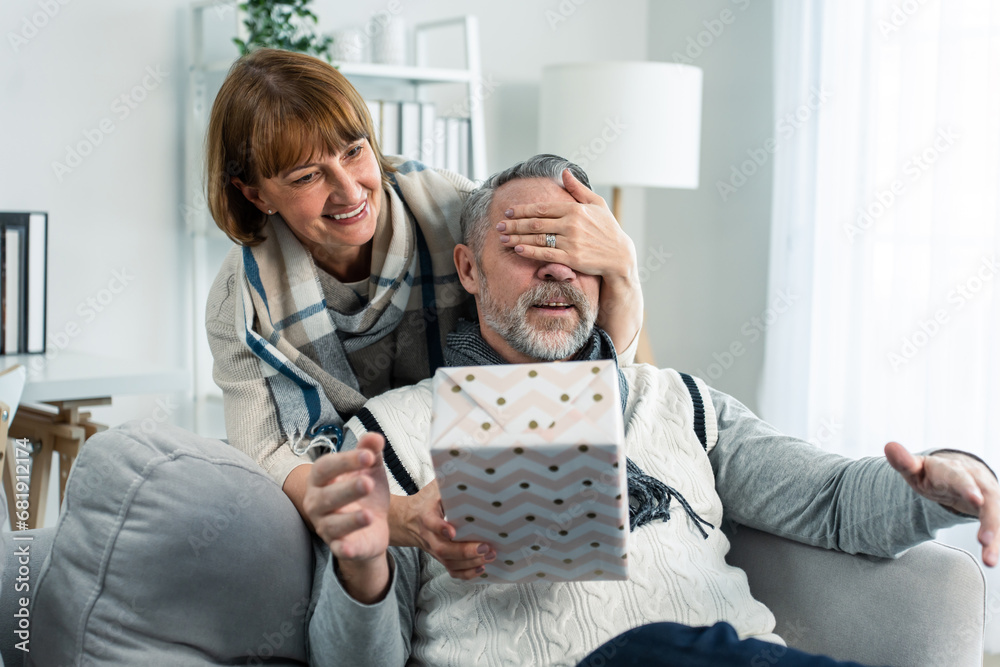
<box><xmin>237</xmin><ymin>158</ymin><xmax>475</xmax><ymax>446</ymax></box>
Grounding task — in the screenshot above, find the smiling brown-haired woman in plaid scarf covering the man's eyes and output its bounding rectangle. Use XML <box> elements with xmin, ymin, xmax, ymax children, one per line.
<box><xmin>206</xmin><ymin>49</ymin><xmax>642</xmax><ymax>569</ymax></box>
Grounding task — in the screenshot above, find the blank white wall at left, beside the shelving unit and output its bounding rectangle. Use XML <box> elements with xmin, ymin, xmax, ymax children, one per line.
<box><xmin>0</xmin><ymin>0</ymin><xmax>187</xmax><ymax>438</ymax></box>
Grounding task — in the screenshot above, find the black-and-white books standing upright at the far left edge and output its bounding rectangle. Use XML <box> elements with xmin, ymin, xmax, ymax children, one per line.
<box><xmin>0</xmin><ymin>212</ymin><xmax>48</xmax><ymax>354</ymax></box>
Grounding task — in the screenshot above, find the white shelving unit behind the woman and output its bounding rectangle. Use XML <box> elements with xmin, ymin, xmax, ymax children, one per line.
<box><xmin>186</xmin><ymin>0</ymin><xmax>487</xmax><ymax>429</ymax></box>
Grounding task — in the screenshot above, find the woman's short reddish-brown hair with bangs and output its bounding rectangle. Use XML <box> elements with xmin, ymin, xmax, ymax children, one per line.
<box><xmin>205</xmin><ymin>49</ymin><xmax>394</xmax><ymax>246</ymax></box>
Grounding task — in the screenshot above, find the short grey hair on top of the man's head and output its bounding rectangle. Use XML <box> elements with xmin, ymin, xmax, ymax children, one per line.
<box><xmin>462</xmin><ymin>154</ymin><xmax>590</xmax><ymax>262</ymax></box>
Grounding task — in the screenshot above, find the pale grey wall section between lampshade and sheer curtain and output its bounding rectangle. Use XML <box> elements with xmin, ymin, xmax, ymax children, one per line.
<box><xmin>640</xmin><ymin>0</ymin><xmax>775</xmax><ymax>409</ymax></box>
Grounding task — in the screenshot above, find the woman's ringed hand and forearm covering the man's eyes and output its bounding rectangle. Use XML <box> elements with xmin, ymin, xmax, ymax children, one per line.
<box><xmin>497</xmin><ymin>169</ymin><xmax>643</xmax><ymax>351</ymax></box>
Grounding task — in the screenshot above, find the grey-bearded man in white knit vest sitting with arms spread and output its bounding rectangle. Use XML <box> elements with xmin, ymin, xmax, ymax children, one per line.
<box><xmin>306</xmin><ymin>156</ymin><xmax>1000</xmax><ymax>666</ymax></box>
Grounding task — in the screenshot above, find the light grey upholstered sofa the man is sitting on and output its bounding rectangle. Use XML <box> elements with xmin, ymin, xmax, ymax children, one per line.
<box><xmin>0</xmin><ymin>423</ymin><xmax>986</xmax><ymax>667</ymax></box>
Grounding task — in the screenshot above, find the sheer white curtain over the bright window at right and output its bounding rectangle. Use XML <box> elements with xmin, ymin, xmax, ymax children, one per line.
<box><xmin>760</xmin><ymin>0</ymin><xmax>1000</xmax><ymax>652</ymax></box>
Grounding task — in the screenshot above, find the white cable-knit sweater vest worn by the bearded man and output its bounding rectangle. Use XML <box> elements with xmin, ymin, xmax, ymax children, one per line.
<box><xmin>348</xmin><ymin>365</ymin><xmax>781</xmax><ymax>667</ymax></box>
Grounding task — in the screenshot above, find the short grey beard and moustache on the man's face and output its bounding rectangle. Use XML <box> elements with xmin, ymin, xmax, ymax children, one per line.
<box><xmin>479</xmin><ymin>271</ymin><xmax>597</xmax><ymax>361</ymax></box>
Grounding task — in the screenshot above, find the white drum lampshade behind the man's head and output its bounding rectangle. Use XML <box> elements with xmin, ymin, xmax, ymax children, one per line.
<box><xmin>539</xmin><ymin>62</ymin><xmax>702</xmax><ymax>188</ymax></box>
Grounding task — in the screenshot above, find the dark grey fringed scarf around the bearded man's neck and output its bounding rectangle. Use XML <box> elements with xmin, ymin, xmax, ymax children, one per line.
<box><xmin>445</xmin><ymin>320</ymin><xmax>714</xmax><ymax>539</ymax></box>
